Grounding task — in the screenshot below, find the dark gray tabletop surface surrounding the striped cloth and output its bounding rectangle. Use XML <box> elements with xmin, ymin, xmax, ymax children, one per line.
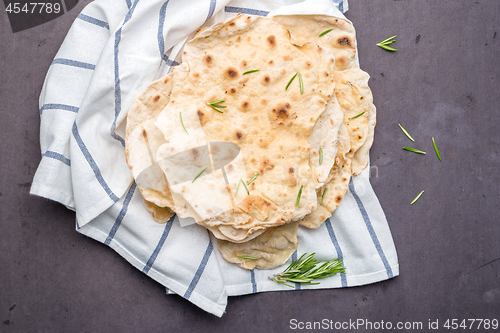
<box><xmin>0</xmin><ymin>0</ymin><xmax>500</xmax><ymax>332</ymax></box>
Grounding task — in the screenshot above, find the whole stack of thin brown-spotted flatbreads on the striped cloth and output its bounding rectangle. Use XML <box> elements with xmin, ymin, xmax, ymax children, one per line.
<box><xmin>126</xmin><ymin>15</ymin><xmax>375</xmax><ymax>269</ymax></box>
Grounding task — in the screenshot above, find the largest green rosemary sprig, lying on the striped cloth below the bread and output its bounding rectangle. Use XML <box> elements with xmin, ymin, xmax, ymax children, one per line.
<box><xmin>269</xmin><ymin>253</ymin><xmax>345</xmax><ymax>288</ymax></box>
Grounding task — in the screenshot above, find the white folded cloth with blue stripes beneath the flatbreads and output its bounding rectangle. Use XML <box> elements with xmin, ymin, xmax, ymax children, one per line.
<box><xmin>31</xmin><ymin>0</ymin><xmax>399</xmax><ymax>316</ymax></box>
